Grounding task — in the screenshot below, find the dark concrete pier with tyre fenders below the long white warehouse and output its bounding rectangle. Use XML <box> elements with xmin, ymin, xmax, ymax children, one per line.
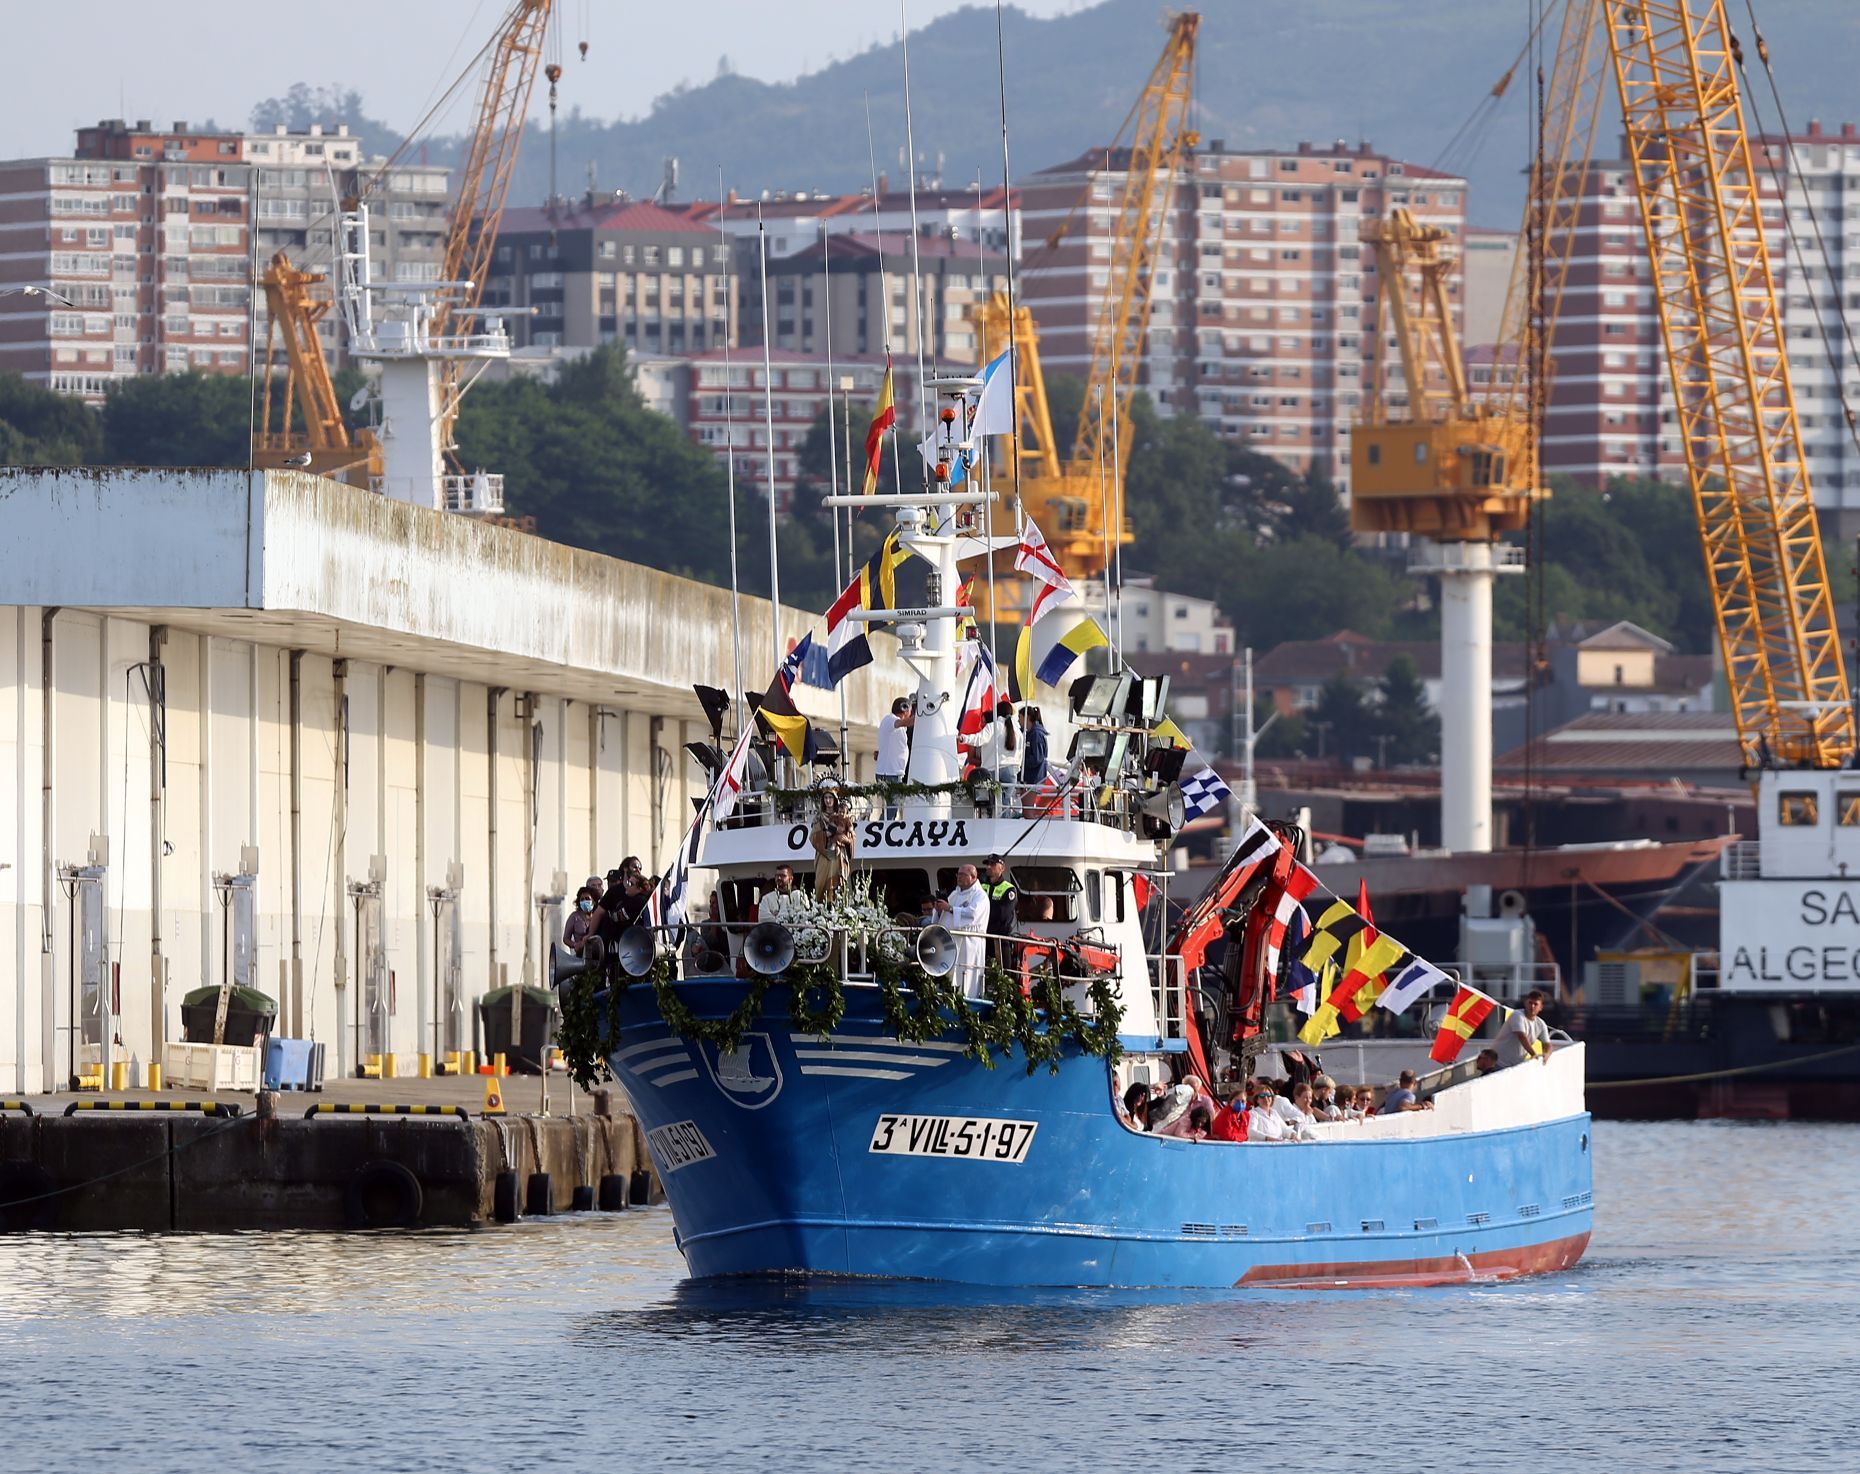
<box><xmin>0</xmin><ymin>1081</ymin><xmax>658</xmax><ymax>1232</ymax></box>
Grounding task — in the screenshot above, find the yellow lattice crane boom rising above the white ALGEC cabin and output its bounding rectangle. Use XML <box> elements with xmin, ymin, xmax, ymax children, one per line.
<box><xmin>1603</xmin><ymin>0</ymin><xmax>1854</xmax><ymax>767</ymax></box>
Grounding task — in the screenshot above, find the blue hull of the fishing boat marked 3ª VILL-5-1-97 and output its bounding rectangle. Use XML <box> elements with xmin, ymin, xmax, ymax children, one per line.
<box><xmin>612</xmin><ymin>981</ymin><xmax>1592</xmax><ymax>1288</ymax></box>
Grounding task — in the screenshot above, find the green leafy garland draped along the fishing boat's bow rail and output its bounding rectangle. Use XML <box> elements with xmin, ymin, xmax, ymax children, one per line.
<box><xmin>556</xmin><ymin>949</ymin><xmax>1123</xmax><ymax>1091</ymax></box>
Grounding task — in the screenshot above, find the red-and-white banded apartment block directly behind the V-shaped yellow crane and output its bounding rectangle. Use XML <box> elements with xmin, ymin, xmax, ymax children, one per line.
<box><xmin>1021</xmin><ymin>140</ymin><xmax>1466</xmax><ymax>488</ymax></box>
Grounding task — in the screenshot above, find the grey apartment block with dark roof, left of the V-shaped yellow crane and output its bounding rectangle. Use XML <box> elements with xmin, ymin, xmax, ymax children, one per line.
<box><xmin>738</xmin><ymin>235</ymin><xmax>1008</xmax><ymax>372</ymax></box>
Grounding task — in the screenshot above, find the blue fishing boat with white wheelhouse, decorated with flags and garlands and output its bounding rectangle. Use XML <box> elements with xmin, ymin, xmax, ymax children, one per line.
<box><xmin>564</xmin><ymin>368</ymin><xmax>1592</xmax><ymax>1286</ymax></box>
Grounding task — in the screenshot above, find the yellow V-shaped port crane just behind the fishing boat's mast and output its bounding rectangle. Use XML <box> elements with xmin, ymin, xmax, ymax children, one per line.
<box><xmin>977</xmin><ymin>11</ymin><xmax>1202</xmax><ymax>620</ymax></box>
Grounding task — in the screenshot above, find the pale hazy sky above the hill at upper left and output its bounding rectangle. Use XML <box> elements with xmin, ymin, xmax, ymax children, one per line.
<box><xmin>0</xmin><ymin>0</ymin><xmax>1086</xmax><ymax>158</ymax></box>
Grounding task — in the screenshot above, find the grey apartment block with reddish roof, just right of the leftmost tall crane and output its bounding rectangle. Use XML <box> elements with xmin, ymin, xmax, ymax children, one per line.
<box><xmin>484</xmin><ymin>197</ymin><xmax>738</xmax><ymax>357</ymax></box>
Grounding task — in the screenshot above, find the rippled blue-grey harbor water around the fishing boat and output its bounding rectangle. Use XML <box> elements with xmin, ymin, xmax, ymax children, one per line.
<box><xmin>0</xmin><ymin>1122</ymin><xmax>1860</xmax><ymax>1474</ymax></box>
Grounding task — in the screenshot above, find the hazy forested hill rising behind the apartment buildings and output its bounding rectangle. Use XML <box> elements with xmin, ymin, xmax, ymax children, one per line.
<box><xmin>275</xmin><ymin>0</ymin><xmax>1860</xmax><ymax>225</ymax></box>
